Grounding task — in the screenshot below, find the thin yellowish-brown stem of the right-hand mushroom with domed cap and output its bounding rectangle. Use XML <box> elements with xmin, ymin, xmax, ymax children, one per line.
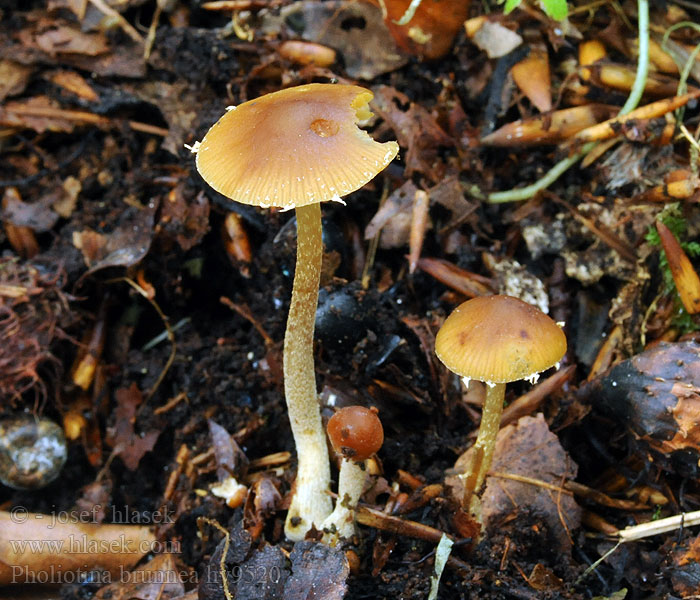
<box><xmin>462</xmin><ymin>383</ymin><xmax>506</xmax><ymax>512</ymax></box>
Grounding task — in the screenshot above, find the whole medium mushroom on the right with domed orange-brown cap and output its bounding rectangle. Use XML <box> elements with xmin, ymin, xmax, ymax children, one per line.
<box><xmin>435</xmin><ymin>295</ymin><xmax>566</xmax><ymax>517</ymax></box>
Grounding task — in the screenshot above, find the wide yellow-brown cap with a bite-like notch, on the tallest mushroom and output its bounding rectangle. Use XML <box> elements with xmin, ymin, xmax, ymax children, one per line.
<box><xmin>197</xmin><ymin>83</ymin><xmax>399</xmax><ymax>209</ymax></box>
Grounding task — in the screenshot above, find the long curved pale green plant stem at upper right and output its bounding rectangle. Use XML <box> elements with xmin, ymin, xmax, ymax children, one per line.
<box><xmin>486</xmin><ymin>0</ymin><xmax>649</xmax><ymax>204</ymax></box>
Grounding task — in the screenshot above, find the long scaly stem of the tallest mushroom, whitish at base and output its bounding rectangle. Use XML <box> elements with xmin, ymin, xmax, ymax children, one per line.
<box><xmin>284</xmin><ymin>204</ymin><xmax>332</xmax><ymax>541</ymax></box>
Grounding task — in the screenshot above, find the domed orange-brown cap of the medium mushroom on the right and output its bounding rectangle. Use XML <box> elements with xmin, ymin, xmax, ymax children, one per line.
<box><xmin>435</xmin><ymin>295</ymin><xmax>566</xmax><ymax>383</ymax></box>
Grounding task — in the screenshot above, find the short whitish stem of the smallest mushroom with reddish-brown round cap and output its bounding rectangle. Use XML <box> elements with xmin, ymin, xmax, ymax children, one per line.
<box><xmin>323</xmin><ymin>458</ymin><xmax>367</xmax><ymax>546</ymax></box>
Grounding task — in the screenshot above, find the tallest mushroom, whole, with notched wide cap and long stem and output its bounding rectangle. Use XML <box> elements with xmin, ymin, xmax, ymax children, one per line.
<box><xmin>193</xmin><ymin>83</ymin><xmax>398</xmax><ymax>541</ymax></box>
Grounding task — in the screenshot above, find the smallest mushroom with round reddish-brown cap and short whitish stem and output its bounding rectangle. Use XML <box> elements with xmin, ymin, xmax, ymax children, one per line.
<box><xmin>323</xmin><ymin>406</ymin><xmax>384</xmax><ymax>545</ymax></box>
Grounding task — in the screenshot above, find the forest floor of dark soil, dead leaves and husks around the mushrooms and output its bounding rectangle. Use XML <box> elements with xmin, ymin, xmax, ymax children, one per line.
<box><xmin>0</xmin><ymin>0</ymin><xmax>700</xmax><ymax>600</ymax></box>
